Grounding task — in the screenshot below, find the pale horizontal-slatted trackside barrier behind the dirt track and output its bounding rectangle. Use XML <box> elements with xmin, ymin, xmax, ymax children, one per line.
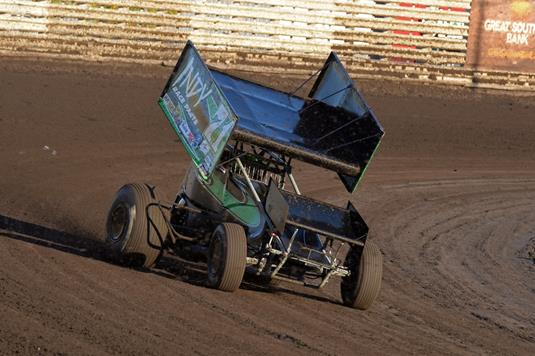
<box><xmin>0</xmin><ymin>0</ymin><xmax>535</xmax><ymax>90</ymax></box>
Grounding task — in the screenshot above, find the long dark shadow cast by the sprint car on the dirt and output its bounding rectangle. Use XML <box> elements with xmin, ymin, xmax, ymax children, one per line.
<box><xmin>0</xmin><ymin>214</ymin><xmax>340</xmax><ymax>305</ymax></box>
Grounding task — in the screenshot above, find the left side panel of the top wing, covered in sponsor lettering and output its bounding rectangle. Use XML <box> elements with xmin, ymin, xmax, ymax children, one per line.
<box><xmin>159</xmin><ymin>41</ymin><xmax>238</xmax><ymax>178</ymax></box>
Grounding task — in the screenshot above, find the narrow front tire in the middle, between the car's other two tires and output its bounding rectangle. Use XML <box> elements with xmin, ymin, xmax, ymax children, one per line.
<box><xmin>207</xmin><ymin>223</ymin><xmax>247</xmax><ymax>292</ymax></box>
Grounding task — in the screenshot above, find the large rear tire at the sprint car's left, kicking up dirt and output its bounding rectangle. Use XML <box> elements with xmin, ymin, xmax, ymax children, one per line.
<box><xmin>106</xmin><ymin>183</ymin><xmax>168</xmax><ymax>268</ymax></box>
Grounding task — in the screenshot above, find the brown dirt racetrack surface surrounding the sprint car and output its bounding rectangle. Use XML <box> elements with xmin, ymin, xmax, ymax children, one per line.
<box><xmin>0</xmin><ymin>61</ymin><xmax>535</xmax><ymax>355</ymax></box>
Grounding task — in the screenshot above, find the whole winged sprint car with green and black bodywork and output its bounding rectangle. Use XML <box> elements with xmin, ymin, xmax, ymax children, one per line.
<box><xmin>106</xmin><ymin>42</ymin><xmax>384</xmax><ymax>309</ymax></box>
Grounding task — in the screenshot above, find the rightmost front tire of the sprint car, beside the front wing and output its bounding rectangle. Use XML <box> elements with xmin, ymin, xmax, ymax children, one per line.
<box><xmin>340</xmin><ymin>241</ymin><xmax>383</xmax><ymax>310</ymax></box>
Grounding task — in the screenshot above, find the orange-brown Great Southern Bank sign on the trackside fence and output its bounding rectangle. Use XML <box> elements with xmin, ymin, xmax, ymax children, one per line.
<box><xmin>467</xmin><ymin>0</ymin><xmax>535</xmax><ymax>73</ymax></box>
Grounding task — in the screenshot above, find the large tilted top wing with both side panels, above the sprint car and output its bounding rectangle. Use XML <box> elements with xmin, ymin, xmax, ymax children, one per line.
<box><xmin>159</xmin><ymin>41</ymin><xmax>384</xmax><ymax>192</ymax></box>
